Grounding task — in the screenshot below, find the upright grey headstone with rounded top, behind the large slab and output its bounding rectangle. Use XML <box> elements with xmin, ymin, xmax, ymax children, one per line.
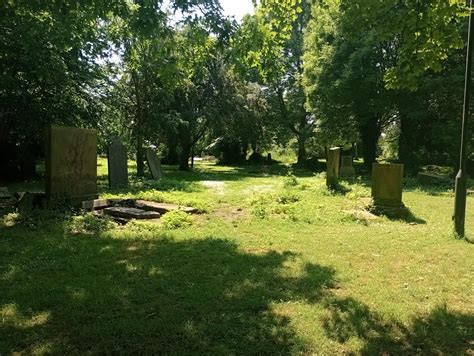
<box><xmin>107</xmin><ymin>140</ymin><xmax>128</xmax><ymax>188</ymax></box>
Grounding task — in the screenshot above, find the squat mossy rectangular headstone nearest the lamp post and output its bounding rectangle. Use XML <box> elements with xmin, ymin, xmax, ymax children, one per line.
<box><xmin>372</xmin><ymin>163</ymin><xmax>404</xmax><ymax>207</ymax></box>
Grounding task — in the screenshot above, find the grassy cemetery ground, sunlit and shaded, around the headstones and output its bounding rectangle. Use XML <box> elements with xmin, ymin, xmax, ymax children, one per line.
<box><xmin>0</xmin><ymin>159</ymin><xmax>474</xmax><ymax>355</ymax></box>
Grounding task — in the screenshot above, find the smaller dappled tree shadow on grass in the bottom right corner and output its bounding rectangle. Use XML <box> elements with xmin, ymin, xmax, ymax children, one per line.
<box><xmin>323</xmin><ymin>298</ymin><xmax>474</xmax><ymax>355</ymax></box>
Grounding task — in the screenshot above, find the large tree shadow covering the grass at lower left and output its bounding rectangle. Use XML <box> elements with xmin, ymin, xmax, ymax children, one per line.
<box><xmin>0</xmin><ymin>218</ymin><xmax>334</xmax><ymax>354</ymax></box>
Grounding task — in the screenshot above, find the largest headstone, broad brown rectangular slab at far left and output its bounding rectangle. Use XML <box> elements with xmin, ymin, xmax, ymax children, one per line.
<box><xmin>46</xmin><ymin>126</ymin><xmax>97</xmax><ymax>201</ymax></box>
